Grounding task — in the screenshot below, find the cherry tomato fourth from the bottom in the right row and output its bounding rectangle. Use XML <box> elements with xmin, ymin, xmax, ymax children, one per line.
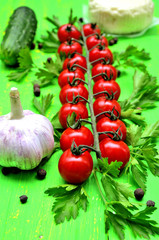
<box><xmin>93</xmin><ymin>78</ymin><xmax>120</xmax><ymax>100</ymax></box>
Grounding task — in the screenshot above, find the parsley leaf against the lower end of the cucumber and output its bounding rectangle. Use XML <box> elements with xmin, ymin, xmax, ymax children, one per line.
<box><xmin>7</xmin><ymin>48</ymin><xmax>33</xmax><ymax>82</ymax></box>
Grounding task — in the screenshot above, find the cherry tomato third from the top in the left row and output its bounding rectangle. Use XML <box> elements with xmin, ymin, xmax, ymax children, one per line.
<box><xmin>63</xmin><ymin>53</ymin><xmax>87</xmax><ymax>73</ymax></box>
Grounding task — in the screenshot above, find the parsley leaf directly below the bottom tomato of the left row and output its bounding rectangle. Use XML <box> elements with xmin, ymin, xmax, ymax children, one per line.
<box><xmin>45</xmin><ymin>184</ymin><xmax>88</xmax><ymax>224</ymax></box>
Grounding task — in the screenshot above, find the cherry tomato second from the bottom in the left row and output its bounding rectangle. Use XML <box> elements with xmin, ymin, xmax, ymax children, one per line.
<box><xmin>60</xmin><ymin>126</ymin><xmax>94</xmax><ymax>151</ymax></box>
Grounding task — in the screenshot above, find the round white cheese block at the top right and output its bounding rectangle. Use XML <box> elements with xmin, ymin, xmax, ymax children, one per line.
<box><xmin>89</xmin><ymin>0</ymin><xmax>154</xmax><ymax>34</ymax></box>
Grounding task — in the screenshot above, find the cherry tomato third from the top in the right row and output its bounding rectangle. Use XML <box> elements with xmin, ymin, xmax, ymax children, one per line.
<box><xmin>89</xmin><ymin>46</ymin><xmax>113</xmax><ymax>66</ymax></box>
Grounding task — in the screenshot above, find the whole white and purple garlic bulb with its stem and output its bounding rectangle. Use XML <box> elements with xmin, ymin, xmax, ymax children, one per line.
<box><xmin>0</xmin><ymin>88</ymin><xmax>54</xmax><ymax>170</ymax></box>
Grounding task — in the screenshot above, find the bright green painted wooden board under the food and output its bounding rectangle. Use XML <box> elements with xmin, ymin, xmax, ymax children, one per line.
<box><xmin>0</xmin><ymin>0</ymin><xmax>159</xmax><ymax>240</ymax></box>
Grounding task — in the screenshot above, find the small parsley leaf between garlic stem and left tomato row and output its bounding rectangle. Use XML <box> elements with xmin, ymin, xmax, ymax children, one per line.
<box><xmin>33</xmin><ymin>93</ymin><xmax>53</xmax><ymax>116</ymax></box>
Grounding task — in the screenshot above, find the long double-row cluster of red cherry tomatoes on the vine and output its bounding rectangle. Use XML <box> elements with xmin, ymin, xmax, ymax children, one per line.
<box><xmin>55</xmin><ymin>24</ymin><xmax>130</xmax><ymax>184</ymax></box>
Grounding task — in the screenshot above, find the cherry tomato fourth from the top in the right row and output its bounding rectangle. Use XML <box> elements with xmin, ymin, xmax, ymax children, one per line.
<box><xmin>92</xmin><ymin>63</ymin><xmax>117</xmax><ymax>82</ymax></box>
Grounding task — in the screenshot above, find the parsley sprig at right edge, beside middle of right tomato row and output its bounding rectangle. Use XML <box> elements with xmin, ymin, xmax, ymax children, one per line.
<box><xmin>120</xmin><ymin>71</ymin><xmax>159</xmax><ymax>125</ymax></box>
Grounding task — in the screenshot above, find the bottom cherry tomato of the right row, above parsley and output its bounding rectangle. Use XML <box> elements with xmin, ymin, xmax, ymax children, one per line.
<box><xmin>99</xmin><ymin>138</ymin><xmax>130</xmax><ymax>168</ymax></box>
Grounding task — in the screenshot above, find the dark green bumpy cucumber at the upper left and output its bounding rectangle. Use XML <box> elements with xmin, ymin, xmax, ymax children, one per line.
<box><xmin>0</xmin><ymin>6</ymin><xmax>37</xmax><ymax>66</ymax></box>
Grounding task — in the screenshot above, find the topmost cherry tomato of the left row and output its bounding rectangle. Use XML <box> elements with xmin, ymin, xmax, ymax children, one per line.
<box><xmin>57</xmin><ymin>24</ymin><xmax>81</xmax><ymax>42</ymax></box>
